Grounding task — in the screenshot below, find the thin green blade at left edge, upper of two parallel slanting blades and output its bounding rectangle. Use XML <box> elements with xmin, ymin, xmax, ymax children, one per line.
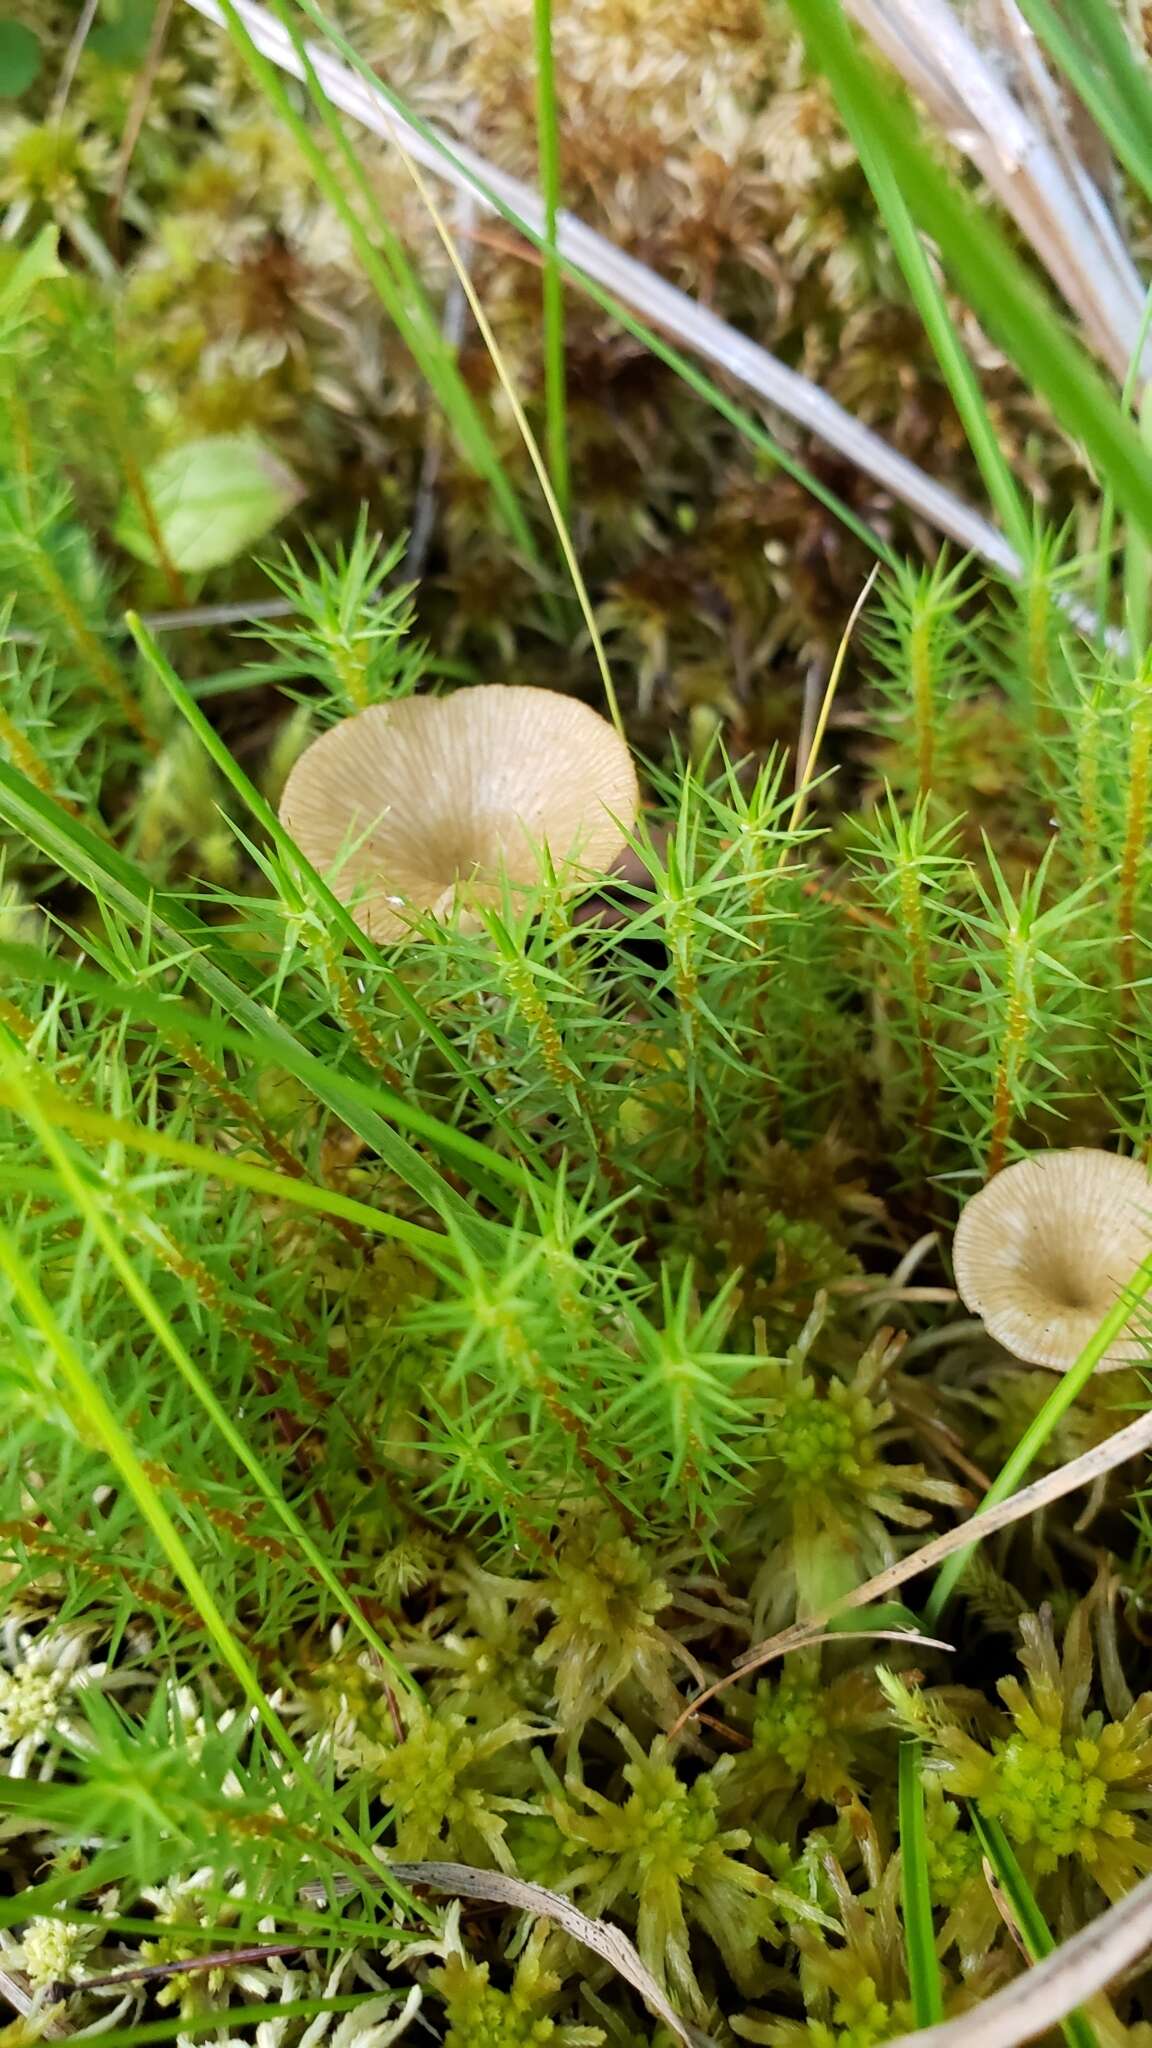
<box><xmin>4</xmin><ymin>1061</ymin><xmax>420</xmax><ymax>1694</ymax></box>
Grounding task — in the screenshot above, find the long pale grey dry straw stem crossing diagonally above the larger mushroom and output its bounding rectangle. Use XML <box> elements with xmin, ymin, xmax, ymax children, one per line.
<box><xmin>187</xmin><ymin>0</ymin><xmax>1021</xmax><ymax>578</ymax></box>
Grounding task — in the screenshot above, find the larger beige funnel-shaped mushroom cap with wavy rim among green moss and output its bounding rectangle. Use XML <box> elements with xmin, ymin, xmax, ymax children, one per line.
<box><xmin>281</xmin><ymin>682</ymin><xmax>640</xmax><ymax>940</ymax></box>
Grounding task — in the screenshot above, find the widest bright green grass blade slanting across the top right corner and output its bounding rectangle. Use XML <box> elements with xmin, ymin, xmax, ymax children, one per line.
<box><xmin>789</xmin><ymin>0</ymin><xmax>1152</xmax><ymax>535</ymax></box>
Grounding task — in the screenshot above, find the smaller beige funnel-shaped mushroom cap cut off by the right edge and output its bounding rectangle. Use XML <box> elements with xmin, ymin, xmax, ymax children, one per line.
<box><xmin>953</xmin><ymin>1147</ymin><xmax>1152</xmax><ymax>1372</ymax></box>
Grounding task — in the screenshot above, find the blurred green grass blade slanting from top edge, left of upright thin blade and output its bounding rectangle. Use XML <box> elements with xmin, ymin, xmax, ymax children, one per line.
<box><xmin>210</xmin><ymin>0</ymin><xmax>543</xmax><ymax>573</ymax></box>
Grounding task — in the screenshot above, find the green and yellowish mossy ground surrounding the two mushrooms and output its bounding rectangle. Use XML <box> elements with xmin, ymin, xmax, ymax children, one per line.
<box><xmin>0</xmin><ymin>0</ymin><xmax>1152</xmax><ymax>2048</ymax></box>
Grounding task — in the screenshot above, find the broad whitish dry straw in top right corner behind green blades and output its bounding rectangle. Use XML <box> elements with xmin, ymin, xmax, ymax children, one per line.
<box><xmin>845</xmin><ymin>0</ymin><xmax>1144</xmax><ymax>383</ymax></box>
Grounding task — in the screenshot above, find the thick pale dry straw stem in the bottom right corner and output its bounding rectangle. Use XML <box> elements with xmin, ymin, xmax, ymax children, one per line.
<box><xmin>888</xmin><ymin>1878</ymin><xmax>1152</xmax><ymax>2048</ymax></box>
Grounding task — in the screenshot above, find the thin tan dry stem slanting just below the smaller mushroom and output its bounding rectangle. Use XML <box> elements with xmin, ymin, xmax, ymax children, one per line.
<box><xmin>668</xmin><ymin>1411</ymin><xmax>1152</xmax><ymax>1735</ymax></box>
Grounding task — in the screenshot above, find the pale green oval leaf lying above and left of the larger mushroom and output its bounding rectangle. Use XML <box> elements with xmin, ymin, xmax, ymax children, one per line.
<box><xmin>115</xmin><ymin>434</ymin><xmax>303</xmax><ymax>573</ymax></box>
